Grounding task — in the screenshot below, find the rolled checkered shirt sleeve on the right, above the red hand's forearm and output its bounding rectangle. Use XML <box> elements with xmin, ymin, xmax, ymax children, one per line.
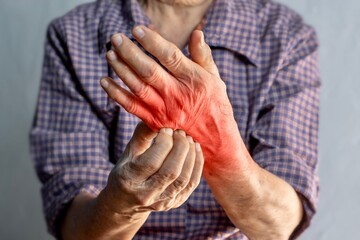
<box><xmin>251</xmin><ymin>24</ymin><xmax>321</xmax><ymax>237</ymax></box>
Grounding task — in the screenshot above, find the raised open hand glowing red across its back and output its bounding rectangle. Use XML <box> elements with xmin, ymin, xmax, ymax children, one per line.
<box><xmin>101</xmin><ymin>26</ymin><xmax>248</xmax><ymax>173</ymax></box>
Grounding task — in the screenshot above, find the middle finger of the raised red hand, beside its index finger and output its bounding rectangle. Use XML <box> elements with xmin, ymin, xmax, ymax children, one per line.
<box><xmin>111</xmin><ymin>34</ymin><xmax>168</xmax><ymax>89</ymax></box>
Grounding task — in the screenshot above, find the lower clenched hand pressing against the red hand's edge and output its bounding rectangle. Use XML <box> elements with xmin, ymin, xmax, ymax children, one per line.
<box><xmin>98</xmin><ymin>123</ymin><xmax>204</xmax><ymax>218</ymax></box>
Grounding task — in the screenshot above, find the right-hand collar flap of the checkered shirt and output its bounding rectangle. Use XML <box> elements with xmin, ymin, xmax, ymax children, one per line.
<box><xmin>203</xmin><ymin>0</ymin><xmax>260</xmax><ymax>66</ymax></box>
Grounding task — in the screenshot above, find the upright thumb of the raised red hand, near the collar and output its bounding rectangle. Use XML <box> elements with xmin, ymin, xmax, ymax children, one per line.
<box><xmin>189</xmin><ymin>30</ymin><xmax>219</xmax><ymax>76</ymax></box>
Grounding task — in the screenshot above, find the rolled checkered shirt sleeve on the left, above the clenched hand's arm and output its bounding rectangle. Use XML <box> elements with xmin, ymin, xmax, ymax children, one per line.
<box><xmin>30</xmin><ymin>21</ymin><xmax>113</xmax><ymax>237</ymax></box>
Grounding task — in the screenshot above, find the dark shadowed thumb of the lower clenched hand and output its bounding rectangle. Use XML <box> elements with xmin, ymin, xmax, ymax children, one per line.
<box><xmin>128</xmin><ymin>122</ymin><xmax>158</xmax><ymax>157</ymax></box>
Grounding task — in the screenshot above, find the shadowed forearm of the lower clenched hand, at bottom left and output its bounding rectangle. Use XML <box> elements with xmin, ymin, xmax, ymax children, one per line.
<box><xmin>61</xmin><ymin>190</ymin><xmax>149</xmax><ymax>240</ymax></box>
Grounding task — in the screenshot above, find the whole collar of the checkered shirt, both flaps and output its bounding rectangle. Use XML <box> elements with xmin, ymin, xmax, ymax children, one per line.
<box><xmin>99</xmin><ymin>0</ymin><xmax>260</xmax><ymax>66</ymax></box>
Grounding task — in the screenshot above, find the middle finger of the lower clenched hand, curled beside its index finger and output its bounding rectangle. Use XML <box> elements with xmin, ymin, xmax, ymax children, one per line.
<box><xmin>149</xmin><ymin>130</ymin><xmax>189</xmax><ymax>195</ymax></box>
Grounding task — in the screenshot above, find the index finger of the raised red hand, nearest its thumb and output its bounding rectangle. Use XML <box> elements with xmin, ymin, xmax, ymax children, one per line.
<box><xmin>133</xmin><ymin>26</ymin><xmax>193</xmax><ymax>77</ymax></box>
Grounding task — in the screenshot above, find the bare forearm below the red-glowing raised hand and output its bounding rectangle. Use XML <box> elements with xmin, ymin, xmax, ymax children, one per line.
<box><xmin>206</xmin><ymin>140</ymin><xmax>303</xmax><ymax>239</ymax></box>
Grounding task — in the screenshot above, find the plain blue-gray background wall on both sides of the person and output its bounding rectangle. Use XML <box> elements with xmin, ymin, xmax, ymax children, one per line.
<box><xmin>0</xmin><ymin>0</ymin><xmax>360</xmax><ymax>240</ymax></box>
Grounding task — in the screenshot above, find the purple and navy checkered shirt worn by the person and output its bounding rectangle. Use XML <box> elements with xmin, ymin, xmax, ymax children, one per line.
<box><xmin>30</xmin><ymin>0</ymin><xmax>320</xmax><ymax>239</ymax></box>
